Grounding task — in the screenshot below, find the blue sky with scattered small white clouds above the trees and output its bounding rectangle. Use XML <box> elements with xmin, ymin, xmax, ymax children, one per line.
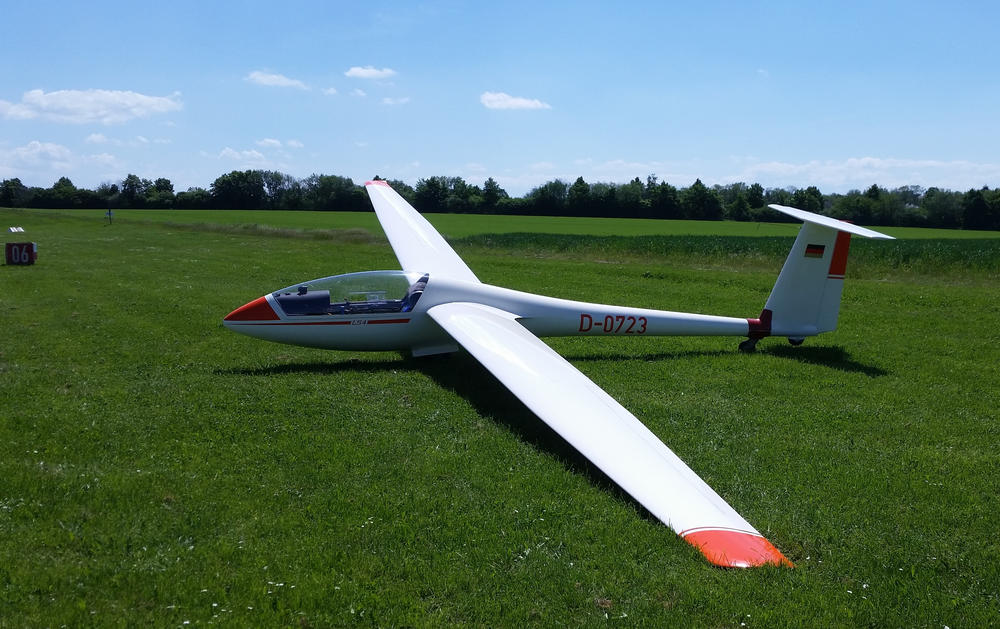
<box><xmin>0</xmin><ymin>0</ymin><xmax>1000</xmax><ymax>196</ymax></box>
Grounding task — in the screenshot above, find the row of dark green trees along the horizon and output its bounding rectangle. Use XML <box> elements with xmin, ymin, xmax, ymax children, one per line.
<box><xmin>0</xmin><ymin>170</ymin><xmax>1000</xmax><ymax>230</ymax></box>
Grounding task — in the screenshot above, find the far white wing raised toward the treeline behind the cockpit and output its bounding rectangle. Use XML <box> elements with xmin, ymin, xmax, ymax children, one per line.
<box><xmin>365</xmin><ymin>181</ymin><xmax>479</xmax><ymax>282</ymax></box>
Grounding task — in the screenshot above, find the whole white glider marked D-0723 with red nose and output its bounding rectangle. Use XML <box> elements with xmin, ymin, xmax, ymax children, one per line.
<box><xmin>224</xmin><ymin>181</ymin><xmax>891</xmax><ymax>567</ymax></box>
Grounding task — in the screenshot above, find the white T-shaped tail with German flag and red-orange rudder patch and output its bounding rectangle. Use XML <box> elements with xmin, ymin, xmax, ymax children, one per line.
<box><xmin>750</xmin><ymin>205</ymin><xmax>892</xmax><ymax>339</ymax></box>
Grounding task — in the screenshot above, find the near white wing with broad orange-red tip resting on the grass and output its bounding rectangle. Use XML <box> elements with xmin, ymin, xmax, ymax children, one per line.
<box><xmin>428</xmin><ymin>302</ymin><xmax>791</xmax><ymax>567</ymax></box>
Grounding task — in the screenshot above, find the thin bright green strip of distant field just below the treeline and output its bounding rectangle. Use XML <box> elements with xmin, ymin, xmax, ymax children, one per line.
<box><xmin>31</xmin><ymin>210</ymin><xmax>1000</xmax><ymax>239</ymax></box>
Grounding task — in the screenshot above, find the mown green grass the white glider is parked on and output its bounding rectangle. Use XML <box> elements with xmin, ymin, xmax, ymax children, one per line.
<box><xmin>0</xmin><ymin>210</ymin><xmax>1000</xmax><ymax>629</ymax></box>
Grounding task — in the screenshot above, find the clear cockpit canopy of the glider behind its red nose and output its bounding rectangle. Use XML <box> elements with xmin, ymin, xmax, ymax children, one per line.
<box><xmin>272</xmin><ymin>271</ymin><xmax>429</xmax><ymax>316</ymax></box>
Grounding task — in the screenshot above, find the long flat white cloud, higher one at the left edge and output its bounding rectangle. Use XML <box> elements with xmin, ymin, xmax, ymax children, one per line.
<box><xmin>0</xmin><ymin>90</ymin><xmax>184</xmax><ymax>125</ymax></box>
